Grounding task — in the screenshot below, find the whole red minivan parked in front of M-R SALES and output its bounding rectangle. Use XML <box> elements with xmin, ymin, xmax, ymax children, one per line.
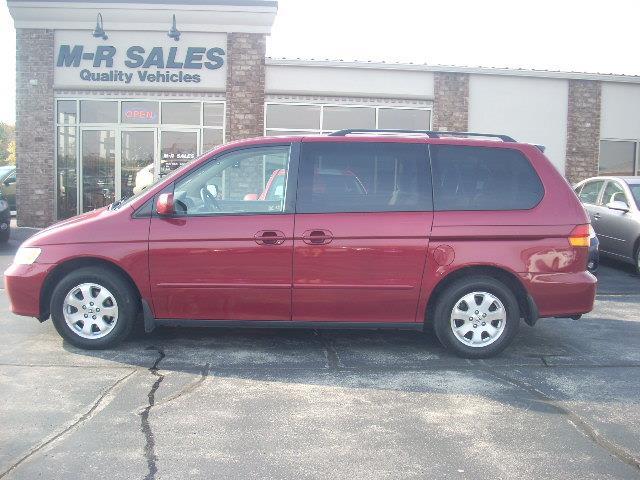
<box><xmin>5</xmin><ymin>130</ymin><xmax>596</xmax><ymax>358</ymax></box>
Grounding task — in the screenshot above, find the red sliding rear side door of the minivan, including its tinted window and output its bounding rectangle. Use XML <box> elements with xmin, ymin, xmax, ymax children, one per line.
<box><xmin>292</xmin><ymin>141</ymin><xmax>433</xmax><ymax>322</ymax></box>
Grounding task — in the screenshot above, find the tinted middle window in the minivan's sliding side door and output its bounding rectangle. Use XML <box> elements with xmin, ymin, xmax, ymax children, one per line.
<box><xmin>296</xmin><ymin>142</ymin><xmax>432</xmax><ymax>213</ymax></box>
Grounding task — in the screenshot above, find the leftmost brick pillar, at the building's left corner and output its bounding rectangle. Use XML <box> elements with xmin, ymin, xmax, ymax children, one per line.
<box><xmin>16</xmin><ymin>29</ymin><xmax>55</xmax><ymax>227</ymax></box>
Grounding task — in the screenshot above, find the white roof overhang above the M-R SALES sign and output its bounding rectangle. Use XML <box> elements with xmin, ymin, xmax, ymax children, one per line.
<box><xmin>7</xmin><ymin>0</ymin><xmax>278</xmax><ymax>35</ymax></box>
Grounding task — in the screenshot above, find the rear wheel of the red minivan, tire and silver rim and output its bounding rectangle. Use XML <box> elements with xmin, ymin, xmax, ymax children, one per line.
<box><xmin>433</xmin><ymin>276</ymin><xmax>520</xmax><ymax>358</ymax></box>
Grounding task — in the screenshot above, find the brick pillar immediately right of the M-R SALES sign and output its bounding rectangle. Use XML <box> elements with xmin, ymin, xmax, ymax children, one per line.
<box><xmin>226</xmin><ymin>33</ymin><xmax>265</xmax><ymax>141</ymax></box>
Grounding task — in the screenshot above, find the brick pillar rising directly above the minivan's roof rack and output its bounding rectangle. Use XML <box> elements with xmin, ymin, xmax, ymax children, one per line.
<box><xmin>433</xmin><ymin>72</ymin><xmax>469</xmax><ymax>132</ymax></box>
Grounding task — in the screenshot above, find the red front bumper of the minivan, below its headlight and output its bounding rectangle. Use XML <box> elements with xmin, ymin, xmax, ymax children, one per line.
<box><xmin>4</xmin><ymin>263</ymin><xmax>54</xmax><ymax>320</ymax></box>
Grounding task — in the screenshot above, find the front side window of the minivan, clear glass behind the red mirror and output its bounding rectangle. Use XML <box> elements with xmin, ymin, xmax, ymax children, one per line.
<box><xmin>174</xmin><ymin>145</ymin><xmax>290</xmax><ymax>215</ymax></box>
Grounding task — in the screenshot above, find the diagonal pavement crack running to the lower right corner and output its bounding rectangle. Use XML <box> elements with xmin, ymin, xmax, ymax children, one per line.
<box><xmin>485</xmin><ymin>369</ymin><xmax>640</xmax><ymax>473</ymax></box>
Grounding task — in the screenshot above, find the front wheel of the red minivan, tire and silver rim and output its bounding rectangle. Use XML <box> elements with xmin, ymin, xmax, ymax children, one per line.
<box><xmin>51</xmin><ymin>267</ymin><xmax>138</xmax><ymax>349</ymax></box>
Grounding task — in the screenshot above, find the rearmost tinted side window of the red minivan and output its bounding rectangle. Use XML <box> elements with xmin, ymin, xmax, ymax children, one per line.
<box><xmin>430</xmin><ymin>145</ymin><xmax>544</xmax><ymax>211</ymax></box>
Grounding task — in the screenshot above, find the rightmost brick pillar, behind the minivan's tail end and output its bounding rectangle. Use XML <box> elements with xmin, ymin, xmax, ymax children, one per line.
<box><xmin>565</xmin><ymin>80</ymin><xmax>602</xmax><ymax>184</ymax></box>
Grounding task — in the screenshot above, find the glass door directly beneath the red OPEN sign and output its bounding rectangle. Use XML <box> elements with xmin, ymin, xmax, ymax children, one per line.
<box><xmin>120</xmin><ymin>128</ymin><xmax>158</xmax><ymax>198</ymax></box>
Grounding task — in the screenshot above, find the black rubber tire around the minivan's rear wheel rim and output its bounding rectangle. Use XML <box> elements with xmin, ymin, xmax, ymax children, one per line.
<box><xmin>432</xmin><ymin>275</ymin><xmax>520</xmax><ymax>358</ymax></box>
